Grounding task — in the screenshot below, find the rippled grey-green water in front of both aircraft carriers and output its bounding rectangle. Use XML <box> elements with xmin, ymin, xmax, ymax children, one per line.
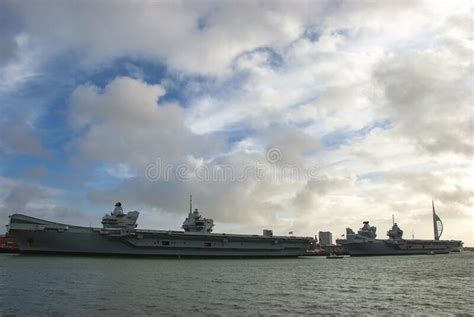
<box><xmin>0</xmin><ymin>253</ymin><xmax>474</xmax><ymax>316</ymax></box>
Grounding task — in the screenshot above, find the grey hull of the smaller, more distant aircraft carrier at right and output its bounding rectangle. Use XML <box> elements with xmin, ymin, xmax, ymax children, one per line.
<box><xmin>339</xmin><ymin>239</ymin><xmax>462</xmax><ymax>256</ymax></box>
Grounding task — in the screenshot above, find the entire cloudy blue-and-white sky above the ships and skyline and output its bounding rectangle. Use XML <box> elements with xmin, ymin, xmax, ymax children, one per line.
<box><xmin>0</xmin><ymin>0</ymin><xmax>474</xmax><ymax>246</ymax></box>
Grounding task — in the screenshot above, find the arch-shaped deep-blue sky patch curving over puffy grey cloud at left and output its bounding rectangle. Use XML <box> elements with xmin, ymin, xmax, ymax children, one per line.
<box><xmin>36</xmin><ymin>53</ymin><xmax>193</xmax><ymax>141</ymax></box>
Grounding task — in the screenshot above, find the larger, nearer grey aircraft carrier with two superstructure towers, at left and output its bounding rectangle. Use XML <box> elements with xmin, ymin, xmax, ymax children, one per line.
<box><xmin>7</xmin><ymin>203</ymin><xmax>315</xmax><ymax>258</ymax></box>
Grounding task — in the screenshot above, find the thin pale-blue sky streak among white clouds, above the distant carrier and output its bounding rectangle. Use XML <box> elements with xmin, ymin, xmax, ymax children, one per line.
<box><xmin>321</xmin><ymin>119</ymin><xmax>392</xmax><ymax>149</ymax></box>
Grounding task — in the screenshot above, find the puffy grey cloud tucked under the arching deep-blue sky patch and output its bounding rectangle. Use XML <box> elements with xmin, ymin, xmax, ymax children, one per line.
<box><xmin>69</xmin><ymin>77</ymin><xmax>220</xmax><ymax>169</ymax></box>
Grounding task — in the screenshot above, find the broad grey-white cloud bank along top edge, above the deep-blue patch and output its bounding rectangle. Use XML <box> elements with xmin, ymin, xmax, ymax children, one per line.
<box><xmin>0</xmin><ymin>1</ymin><xmax>324</xmax><ymax>74</ymax></box>
